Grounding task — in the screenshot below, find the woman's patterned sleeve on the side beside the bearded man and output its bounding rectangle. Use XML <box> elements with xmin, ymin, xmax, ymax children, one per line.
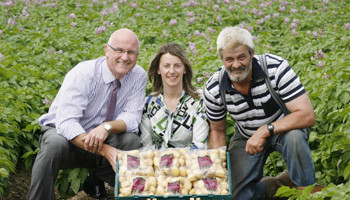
<box><xmin>193</xmin><ymin>99</ymin><xmax>209</xmax><ymax>149</ymax></box>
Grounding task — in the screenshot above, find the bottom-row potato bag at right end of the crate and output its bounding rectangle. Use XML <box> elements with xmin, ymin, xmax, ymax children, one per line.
<box><xmin>193</xmin><ymin>177</ymin><xmax>229</xmax><ymax>195</ymax></box>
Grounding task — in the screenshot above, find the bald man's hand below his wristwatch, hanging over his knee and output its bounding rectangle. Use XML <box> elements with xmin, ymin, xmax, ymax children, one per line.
<box><xmin>83</xmin><ymin>125</ymin><xmax>108</xmax><ymax>153</ymax></box>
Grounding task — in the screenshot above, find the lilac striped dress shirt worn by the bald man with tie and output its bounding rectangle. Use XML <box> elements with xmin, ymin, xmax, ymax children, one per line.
<box><xmin>39</xmin><ymin>57</ymin><xmax>147</xmax><ymax>140</ymax></box>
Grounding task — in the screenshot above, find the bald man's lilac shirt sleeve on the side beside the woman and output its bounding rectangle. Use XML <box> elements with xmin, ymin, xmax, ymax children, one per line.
<box><xmin>117</xmin><ymin>71</ymin><xmax>147</xmax><ymax>132</ymax></box>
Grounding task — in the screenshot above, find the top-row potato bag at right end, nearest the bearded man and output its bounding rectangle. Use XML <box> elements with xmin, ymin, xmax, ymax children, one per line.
<box><xmin>185</xmin><ymin>149</ymin><xmax>227</xmax><ymax>181</ymax></box>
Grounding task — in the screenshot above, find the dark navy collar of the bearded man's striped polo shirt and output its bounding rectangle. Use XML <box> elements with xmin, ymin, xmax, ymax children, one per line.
<box><xmin>219</xmin><ymin>57</ymin><xmax>266</xmax><ymax>92</ymax></box>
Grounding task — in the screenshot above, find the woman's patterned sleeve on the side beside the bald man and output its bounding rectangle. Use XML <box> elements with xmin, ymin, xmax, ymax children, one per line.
<box><xmin>140</xmin><ymin>96</ymin><xmax>154</xmax><ymax>147</ymax></box>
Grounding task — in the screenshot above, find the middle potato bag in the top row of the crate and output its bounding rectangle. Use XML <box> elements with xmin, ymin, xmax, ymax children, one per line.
<box><xmin>153</xmin><ymin>149</ymin><xmax>187</xmax><ymax>177</ymax></box>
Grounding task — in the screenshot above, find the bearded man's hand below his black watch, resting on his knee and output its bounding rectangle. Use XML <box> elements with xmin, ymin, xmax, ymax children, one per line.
<box><xmin>245</xmin><ymin>125</ymin><xmax>270</xmax><ymax>155</ymax></box>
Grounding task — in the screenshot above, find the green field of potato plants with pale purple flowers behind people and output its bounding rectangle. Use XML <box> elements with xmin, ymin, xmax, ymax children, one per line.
<box><xmin>0</xmin><ymin>0</ymin><xmax>350</xmax><ymax>200</ymax></box>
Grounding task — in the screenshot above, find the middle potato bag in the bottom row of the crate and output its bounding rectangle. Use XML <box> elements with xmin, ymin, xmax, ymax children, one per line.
<box><xmin>156</xmin><ymin>175</ymin><xmax>192</xmax><ymax>196</ymax></box>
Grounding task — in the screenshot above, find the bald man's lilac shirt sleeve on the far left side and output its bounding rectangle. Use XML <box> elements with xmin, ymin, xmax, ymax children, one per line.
<box><xmin>55</xmin><ymin>67</ymin><xmax>92</xmax><ymax>140</ymax></box>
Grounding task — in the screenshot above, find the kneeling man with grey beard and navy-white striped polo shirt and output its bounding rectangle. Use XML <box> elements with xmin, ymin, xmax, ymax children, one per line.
<box><xmin>204</xmin><ymin>27</ymin><xmax>315</xmax><ymax>200</ymax></box>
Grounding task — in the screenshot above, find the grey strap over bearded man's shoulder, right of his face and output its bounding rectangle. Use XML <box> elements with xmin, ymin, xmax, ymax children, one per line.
<box><xmin>259</xmin><ymin>54</ymin><xmax>290</xmax><ymax>115</ymax></box>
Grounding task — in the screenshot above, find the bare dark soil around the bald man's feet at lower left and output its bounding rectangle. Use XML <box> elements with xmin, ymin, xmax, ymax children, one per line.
<box><xmin>0</xmin><ymin>163</ymin><xmax>114</xmax><ymax>200</ymax></box>
